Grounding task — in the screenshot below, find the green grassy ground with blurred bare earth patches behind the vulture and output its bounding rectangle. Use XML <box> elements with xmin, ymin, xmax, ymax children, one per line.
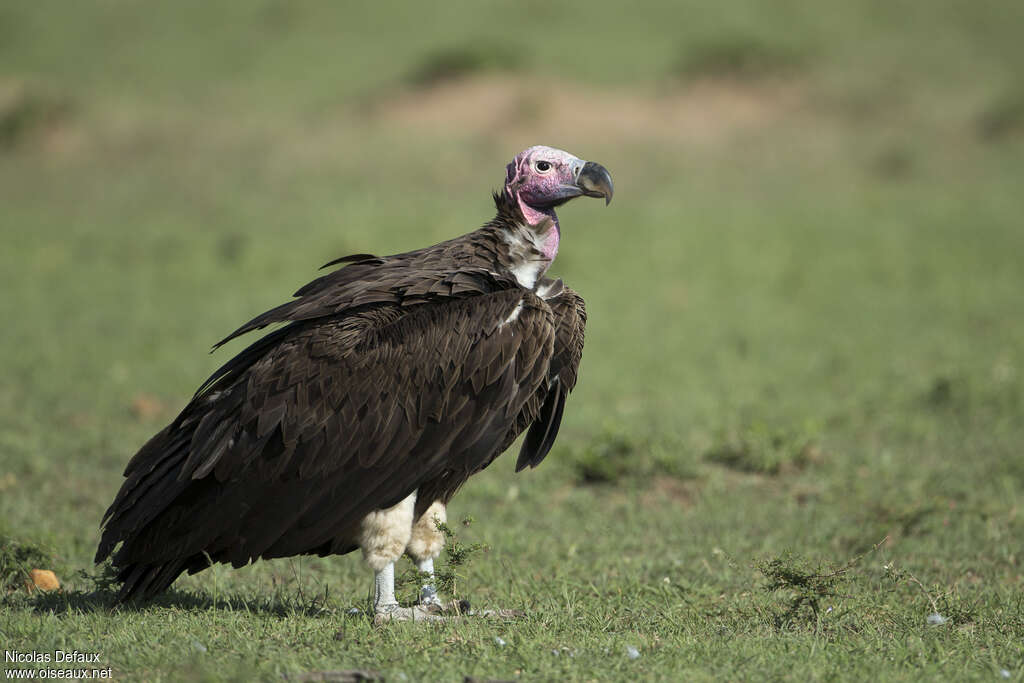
<box><xmin>0</xmin><ymin>0</ymin><xmax>1024</xmax><ymax>680</ymax></box>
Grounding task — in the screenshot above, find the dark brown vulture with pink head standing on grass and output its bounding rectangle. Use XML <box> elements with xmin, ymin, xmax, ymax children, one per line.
<box><xmin>95</xmin><ymin>145</ymin><xmax>613</xmax><ymax>620</ymax></box>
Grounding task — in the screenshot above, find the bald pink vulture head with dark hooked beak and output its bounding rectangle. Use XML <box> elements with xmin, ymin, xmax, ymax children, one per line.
<box><xmin>504</xmin><ymin>145</ymin><xmax>614</xmax><ymax>226</ymax></box>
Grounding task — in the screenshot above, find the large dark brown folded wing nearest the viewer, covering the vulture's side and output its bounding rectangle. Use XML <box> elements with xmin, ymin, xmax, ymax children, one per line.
<box><xmin>97</xmin><ymin>290</ymin><xmax>556</xmax><ymax>598</ymax></box>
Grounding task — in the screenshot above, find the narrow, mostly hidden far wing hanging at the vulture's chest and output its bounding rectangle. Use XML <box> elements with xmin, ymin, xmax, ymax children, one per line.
<box><xmin>515</xmin><ymin>286</ymin><xmax>587</xmax><ymax>472</ymax></box>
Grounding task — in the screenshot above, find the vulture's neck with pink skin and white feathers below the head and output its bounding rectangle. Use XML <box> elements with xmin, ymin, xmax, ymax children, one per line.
<box><xmin>492</xmin><ymin>192</ymin><xmax>561</xmax><ymax>290</ymax></box>
